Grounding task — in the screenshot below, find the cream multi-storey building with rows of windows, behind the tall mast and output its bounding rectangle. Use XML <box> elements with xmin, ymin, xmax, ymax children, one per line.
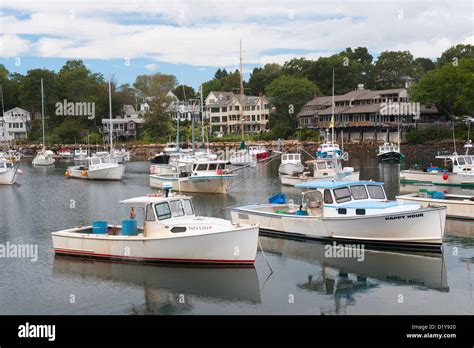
<box><xmin>204</xmin><ymin>91</ymin><xmax>270</xmax><ymax>135</ymax></box>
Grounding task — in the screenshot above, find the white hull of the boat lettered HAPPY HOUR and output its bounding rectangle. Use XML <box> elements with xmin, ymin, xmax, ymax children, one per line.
<box><xmin>231</xmin><ymin>205</ymin><xmax>446</xmax><ymax>249</ymax></box>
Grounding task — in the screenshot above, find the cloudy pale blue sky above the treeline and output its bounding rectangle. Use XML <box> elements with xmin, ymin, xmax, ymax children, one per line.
<box><xmin>0</xmin><ymin>0</ymin><xmax>474</xmax><ymax>87</ymax></box>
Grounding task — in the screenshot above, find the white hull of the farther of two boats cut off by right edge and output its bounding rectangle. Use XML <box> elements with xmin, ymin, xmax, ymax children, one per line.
<box><xmin>400</xmin><ymin>170</ymin><xmax>474</xmax><ymax>186</ymax></box>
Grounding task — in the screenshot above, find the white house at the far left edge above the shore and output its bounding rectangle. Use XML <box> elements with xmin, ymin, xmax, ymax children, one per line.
<box><xmin>0</xmin><ymin>107</ymin><xmax>31</xmax><ymax>142</ymax></box>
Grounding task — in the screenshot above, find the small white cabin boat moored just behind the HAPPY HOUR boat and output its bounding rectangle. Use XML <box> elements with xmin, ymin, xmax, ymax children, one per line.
<box><xmin>280</xmin><ymin>159</ymin><xmax>359</xmax><ymax>186</ymax></box>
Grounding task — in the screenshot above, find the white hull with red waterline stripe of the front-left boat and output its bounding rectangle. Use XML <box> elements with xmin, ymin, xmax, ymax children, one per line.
<box><xmin>52</xmin><ymin>226</ymin><xmax>258</xmax><ymax>264</ymax></box>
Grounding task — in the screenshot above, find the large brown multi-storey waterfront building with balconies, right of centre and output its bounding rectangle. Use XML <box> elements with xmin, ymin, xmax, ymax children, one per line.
<box><xmin>296</xmin><ymin>85</ymin><xmax>440</xmax><ymax>141</ymax></box>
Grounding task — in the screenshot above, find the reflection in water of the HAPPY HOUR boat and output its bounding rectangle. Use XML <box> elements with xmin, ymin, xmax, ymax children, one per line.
<box><xmin>260</xmin><ymin>237</ymin><xmax>449</xmax><ymax>294</ymax></box>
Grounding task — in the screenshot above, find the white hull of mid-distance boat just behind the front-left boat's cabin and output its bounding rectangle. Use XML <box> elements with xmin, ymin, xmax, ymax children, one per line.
<box><xmin>150</xmin><ymin>174</ymin><xmax>237</xmax><ymax>193</ymax></box>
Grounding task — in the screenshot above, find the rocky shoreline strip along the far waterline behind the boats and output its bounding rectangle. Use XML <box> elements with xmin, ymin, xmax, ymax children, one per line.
<box><xmin>13</xmin><ymin>140</ymin><xmax>464</xmax><ymax>160</ymax></box>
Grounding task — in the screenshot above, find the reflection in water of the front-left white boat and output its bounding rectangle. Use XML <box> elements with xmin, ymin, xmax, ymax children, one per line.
<box><xmin>53</xmin><ymin>255</ymin><xmax>260</xmax><ymax>305</ymax></box>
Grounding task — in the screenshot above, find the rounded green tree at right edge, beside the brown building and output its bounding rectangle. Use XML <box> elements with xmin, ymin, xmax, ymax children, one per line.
<box><xmin>410</xmin><ymin>58</ymin><xmax>474</xmax><ymax>116</ymax></box>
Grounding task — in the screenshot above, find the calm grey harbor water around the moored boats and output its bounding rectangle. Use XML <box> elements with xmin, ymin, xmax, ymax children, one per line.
<box><xmin>0</xmin><ymin>159</ymin><xmax>474</xmax><ymax>314</ymax></box>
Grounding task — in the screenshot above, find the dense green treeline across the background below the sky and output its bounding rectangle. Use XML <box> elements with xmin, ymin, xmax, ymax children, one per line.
<box><xmin>0</xmin><ymin>44</ymin><xmax>474</xmax><ymax>143</ymax></box>
